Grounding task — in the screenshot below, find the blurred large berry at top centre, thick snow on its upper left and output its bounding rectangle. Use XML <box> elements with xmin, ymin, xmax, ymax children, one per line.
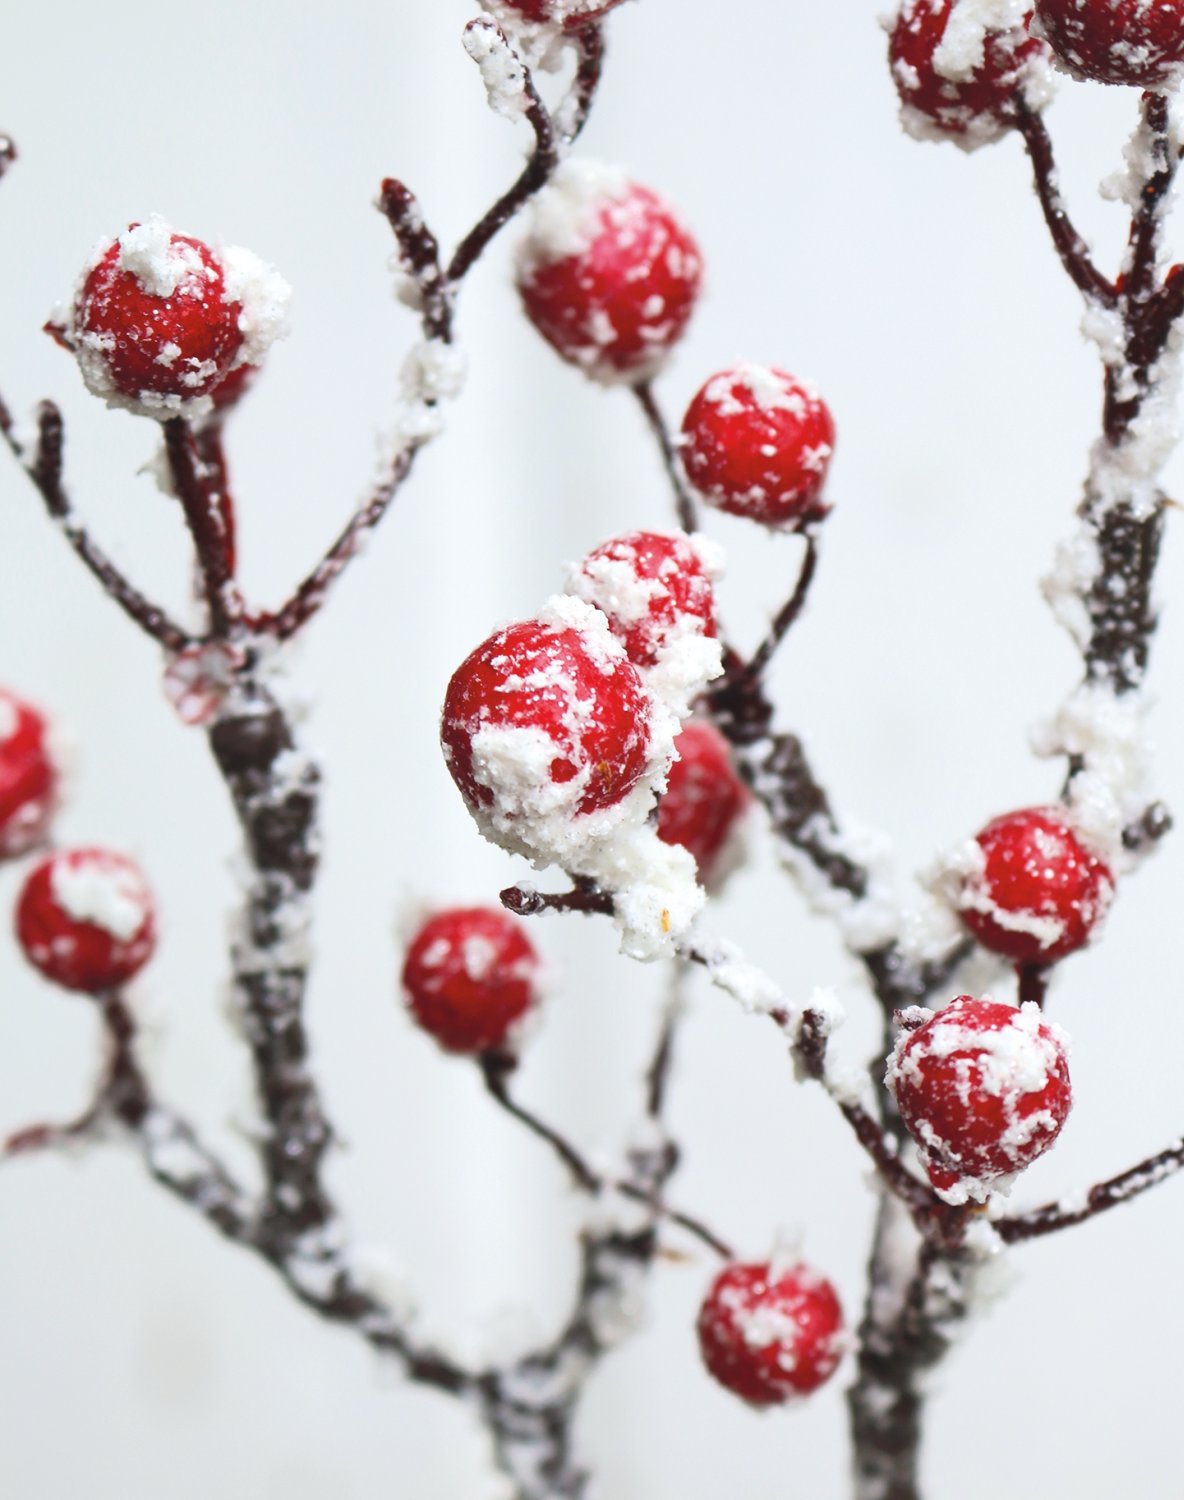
<box><xmin>516</xmin><ymin>161</ymin><xmax>701</xmax><ymax>381</ymax></box>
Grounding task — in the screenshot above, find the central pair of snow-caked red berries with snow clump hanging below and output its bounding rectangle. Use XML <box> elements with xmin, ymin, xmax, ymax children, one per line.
<box><xmin>441</xmin><ymin>533</ymin><xmax>720</xmax><ymax>957</ymax></box>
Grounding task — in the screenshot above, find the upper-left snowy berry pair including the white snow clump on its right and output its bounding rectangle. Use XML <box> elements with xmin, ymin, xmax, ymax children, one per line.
<box><xmin>62</xmin><ymin>218</ymin><xmax>288</xmax><ymax>419</ymax></box>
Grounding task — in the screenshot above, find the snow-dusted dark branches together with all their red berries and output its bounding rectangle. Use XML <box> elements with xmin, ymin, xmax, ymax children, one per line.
<box><xmin>0</xmin><ymin>0</ymin><xmax>1184</xmax><ymax>1500</ymax></box>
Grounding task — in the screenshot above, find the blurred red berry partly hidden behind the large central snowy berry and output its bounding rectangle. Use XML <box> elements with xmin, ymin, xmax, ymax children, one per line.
<box><xmin>657</xmin><ymin>720</ymin><xmax>750</xmax><ymax>882</ymax></box>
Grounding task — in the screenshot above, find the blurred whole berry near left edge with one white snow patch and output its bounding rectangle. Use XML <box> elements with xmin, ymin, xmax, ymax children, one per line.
<box><xmin>17</xmin><ymin>849</ymin><xmax>156</xmax><ymax>995</ymax></box>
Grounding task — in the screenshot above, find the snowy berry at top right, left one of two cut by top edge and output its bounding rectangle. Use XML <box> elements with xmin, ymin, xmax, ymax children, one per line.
<box><xmin>888</xmin><ymin>0</ymin><xmax>1050</xmax><ymax>150</ymax></box>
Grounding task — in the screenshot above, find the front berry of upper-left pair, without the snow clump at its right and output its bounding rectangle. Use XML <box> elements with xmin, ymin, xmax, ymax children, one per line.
<box><xmin>74</xmin><ymin>221</ymin><xmax>243</xmax><ymax>405</ymax></box>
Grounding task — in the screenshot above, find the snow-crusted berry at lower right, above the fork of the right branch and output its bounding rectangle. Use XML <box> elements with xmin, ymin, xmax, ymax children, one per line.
<box><xmin>887</xmin><ymin>995</ymin><xmax>1073</xmax><ymax>1205</ymax></box>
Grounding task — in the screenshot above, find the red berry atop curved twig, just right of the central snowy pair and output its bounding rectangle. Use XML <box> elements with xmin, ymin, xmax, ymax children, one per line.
<box><xmin>683</xmin><ymin>363</ymin><xmax>834</xmax><ymax>527</ymax></box>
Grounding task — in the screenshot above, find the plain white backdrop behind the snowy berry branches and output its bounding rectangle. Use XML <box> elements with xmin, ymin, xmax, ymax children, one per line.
<box><xmin>0</xmin><ymin>0</ymin><xmax>1184</xmax><ymax>1500</ymax></box>
